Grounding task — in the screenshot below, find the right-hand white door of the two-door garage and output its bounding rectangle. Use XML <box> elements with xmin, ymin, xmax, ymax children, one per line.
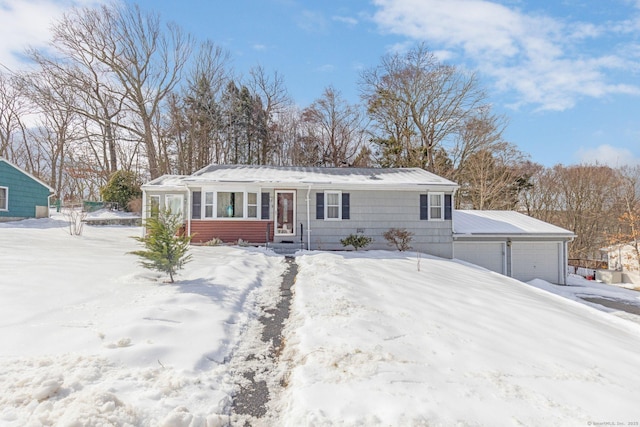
<box><xmin>511</xmin><ymin>242</ymin><xmax>560</xmax><ymax>283</ymax></box>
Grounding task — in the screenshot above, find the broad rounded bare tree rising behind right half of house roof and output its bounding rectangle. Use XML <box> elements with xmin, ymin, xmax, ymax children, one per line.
<box><xmin>361</xmin><ymin>45</ymin><xmax>485</xmax><ymax>172</ymax></box>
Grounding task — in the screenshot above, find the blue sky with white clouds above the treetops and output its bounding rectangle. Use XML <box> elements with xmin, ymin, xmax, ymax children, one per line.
<box><xmin>0</xmin><ymin>0</ymin><xmax>640</xmax><ymax>166</ymax></box>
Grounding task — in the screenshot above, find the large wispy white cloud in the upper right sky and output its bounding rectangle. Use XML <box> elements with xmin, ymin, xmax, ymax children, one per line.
<box><xmin>374</xmin><ymin>0</ymin><xmax>640</xmax><ymax>110</ymax></box>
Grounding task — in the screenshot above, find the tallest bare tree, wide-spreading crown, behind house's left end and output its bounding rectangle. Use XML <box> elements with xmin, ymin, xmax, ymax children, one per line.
<box><xmin>54</xmin><ymin>5</ymin><xmax>192</xmax><ymax>178</ymax></box>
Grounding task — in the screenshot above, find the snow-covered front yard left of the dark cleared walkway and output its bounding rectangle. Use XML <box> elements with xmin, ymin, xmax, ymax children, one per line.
<box><xmin>0</xmin><ymin>219</ymin><xmax>284</xmax><ymax>427</ymax></box>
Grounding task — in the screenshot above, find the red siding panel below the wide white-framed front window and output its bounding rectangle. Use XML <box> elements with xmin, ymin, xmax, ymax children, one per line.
<box><xmin>191</xmin><ymin>220</ymin><xmax>273</xmax><ymax>243</ymax></box>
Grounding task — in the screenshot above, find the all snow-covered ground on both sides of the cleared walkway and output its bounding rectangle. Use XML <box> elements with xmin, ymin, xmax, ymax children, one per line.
<box><xmin>0</xmin><ymin>217</ymin><xmax>640</xmax><ymax>427</ymax></box>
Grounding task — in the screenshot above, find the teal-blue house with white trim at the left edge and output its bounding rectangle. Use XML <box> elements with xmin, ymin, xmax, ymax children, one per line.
<box><xmin>0</xmin><ymin>158</ymin><xmax>54</xmax><ymax>221</ymax></box>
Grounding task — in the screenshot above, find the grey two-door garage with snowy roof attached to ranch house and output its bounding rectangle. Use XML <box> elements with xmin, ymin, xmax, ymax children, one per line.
<box><xmin>453</xmin><ymin>210</ymin><xmax>575</xmax><ymax>285</ymax></box>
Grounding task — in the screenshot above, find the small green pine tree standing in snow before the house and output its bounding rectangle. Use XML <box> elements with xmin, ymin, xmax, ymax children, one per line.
<box><xmin>129</xmin><ymin>209</ymin><xmax>191</xmax><ymax>283</ymax></box>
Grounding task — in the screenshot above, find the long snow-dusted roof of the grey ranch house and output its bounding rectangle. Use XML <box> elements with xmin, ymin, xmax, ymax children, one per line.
<box><xmin>146</xmin><ymin>165</ymin><xmax>457</xmax><ymax>188</ymax></box>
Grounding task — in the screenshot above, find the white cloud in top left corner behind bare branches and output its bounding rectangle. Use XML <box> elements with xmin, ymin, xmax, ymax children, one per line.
<box><xmin>0</xmin><ymin>0</ymin><xmax>106</xmax><ymax>70</ymax></box>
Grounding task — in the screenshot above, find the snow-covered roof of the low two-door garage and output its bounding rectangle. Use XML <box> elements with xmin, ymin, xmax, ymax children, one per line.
<box><xmin>453</xmin><ymin>210</ymin><xmax>574</xmax><ymax>237</ymax></box>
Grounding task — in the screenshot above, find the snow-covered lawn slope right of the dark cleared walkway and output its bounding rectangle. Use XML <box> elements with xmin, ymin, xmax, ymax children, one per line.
<box><xmin>279</xmin><ymin>251</ymin><xmax>640</xmax><ymax>426</ymax></box>
